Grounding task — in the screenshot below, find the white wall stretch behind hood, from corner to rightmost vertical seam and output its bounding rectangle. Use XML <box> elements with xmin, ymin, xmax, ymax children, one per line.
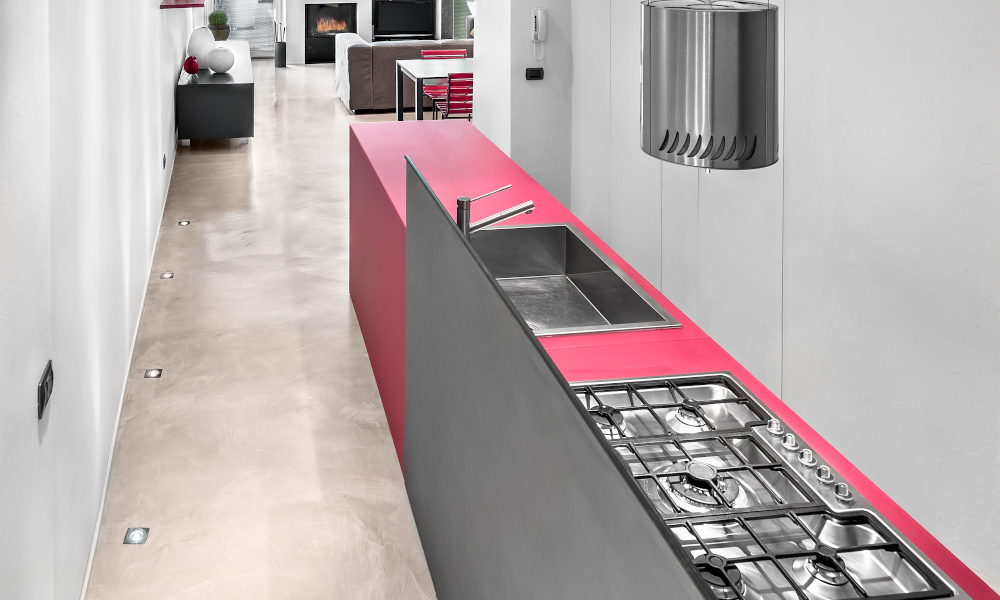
<box><xmin>592</xmin><ymin>0</ymin><xmax>783</xmax><ymax>394</ymax></box>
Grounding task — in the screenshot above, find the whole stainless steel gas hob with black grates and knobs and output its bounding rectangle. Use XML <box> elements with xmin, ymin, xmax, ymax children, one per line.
<box><xmin>573</xmin><ymin>373</ymin><xmax>967</xmax><ymax>600</ymax></box>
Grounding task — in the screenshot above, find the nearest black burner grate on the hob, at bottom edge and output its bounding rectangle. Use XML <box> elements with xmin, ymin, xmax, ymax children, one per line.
<box><xmin>670</xmin><ymin>509</ymin><xmax>950</xmax><ymax>600</ymax></box>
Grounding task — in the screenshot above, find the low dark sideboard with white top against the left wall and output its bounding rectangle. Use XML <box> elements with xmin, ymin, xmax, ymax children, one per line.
<box><xmin>175</xmin><ymin>40</ymin><xmax>254</xmax><ymax>140</ymax></box>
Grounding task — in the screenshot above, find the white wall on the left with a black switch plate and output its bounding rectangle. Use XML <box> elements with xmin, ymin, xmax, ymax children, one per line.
<box><xmin>0</xmin><ymin>0</ymin><xmax>193</xmax><ymax>600</ymax></box>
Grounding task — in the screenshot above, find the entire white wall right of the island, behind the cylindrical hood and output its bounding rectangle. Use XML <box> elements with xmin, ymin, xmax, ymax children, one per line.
<box><xmin>568</xmin><ymin>0</ymin><xmax>1000</xmax><ymax>589</ymax></box>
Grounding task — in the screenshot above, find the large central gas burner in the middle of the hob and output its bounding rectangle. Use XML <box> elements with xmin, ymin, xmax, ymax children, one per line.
<box><xmin>662</xmin><ymin>460</ymin><xmax>750</xmax><ymax>513</ymax></box>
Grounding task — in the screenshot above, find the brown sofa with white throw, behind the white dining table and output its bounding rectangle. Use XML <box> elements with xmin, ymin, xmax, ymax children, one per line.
<box><xmin>335</xmin><ymin>33</ymin><xmax>473</xmax><ymax>112</ymax></box>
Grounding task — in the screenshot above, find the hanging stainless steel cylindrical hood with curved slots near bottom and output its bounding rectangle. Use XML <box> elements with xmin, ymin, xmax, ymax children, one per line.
<box><xmin>642</xmin><ymin>0</ymin><xmax>778</xmax><ymax>169</ymax></box>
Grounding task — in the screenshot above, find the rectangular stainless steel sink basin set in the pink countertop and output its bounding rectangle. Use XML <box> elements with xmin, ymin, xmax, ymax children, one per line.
<box><xmin>472</xmin><ymin>223</ymin><xmax>680</xmax><ymax>335</ymax></box>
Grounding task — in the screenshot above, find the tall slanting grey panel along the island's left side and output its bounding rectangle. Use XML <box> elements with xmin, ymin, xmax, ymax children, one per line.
<box><xmin>404</xmin><ymin>159</ymin><xmax>713</xmax><ymax>600</ymax></box>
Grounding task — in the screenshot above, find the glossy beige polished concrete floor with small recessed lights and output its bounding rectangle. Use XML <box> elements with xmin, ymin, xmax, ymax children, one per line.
<box><xmin>87</xmin><ymin>61</ymin><xmax>434</xmax><ymax>600</ymax></box>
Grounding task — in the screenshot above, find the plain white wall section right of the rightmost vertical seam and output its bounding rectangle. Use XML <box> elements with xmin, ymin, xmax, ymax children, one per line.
<box><xmin>780</xmin><ymin>0</ymin><xmax>1000</xmax><ymax>590</ymax></box>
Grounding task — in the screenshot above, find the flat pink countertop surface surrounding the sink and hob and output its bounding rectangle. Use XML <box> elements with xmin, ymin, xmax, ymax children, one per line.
<box><xmin>351</xmin><ymin>121</ymin><xmax>1000</xmax><ymax>600</ymax></box>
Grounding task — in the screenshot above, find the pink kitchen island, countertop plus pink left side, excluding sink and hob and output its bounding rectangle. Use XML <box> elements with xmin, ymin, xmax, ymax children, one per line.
<box><xmin>350</xmin><ymin>121</ymin><xmax>997</xmax><ymax>599</ymax></box>
